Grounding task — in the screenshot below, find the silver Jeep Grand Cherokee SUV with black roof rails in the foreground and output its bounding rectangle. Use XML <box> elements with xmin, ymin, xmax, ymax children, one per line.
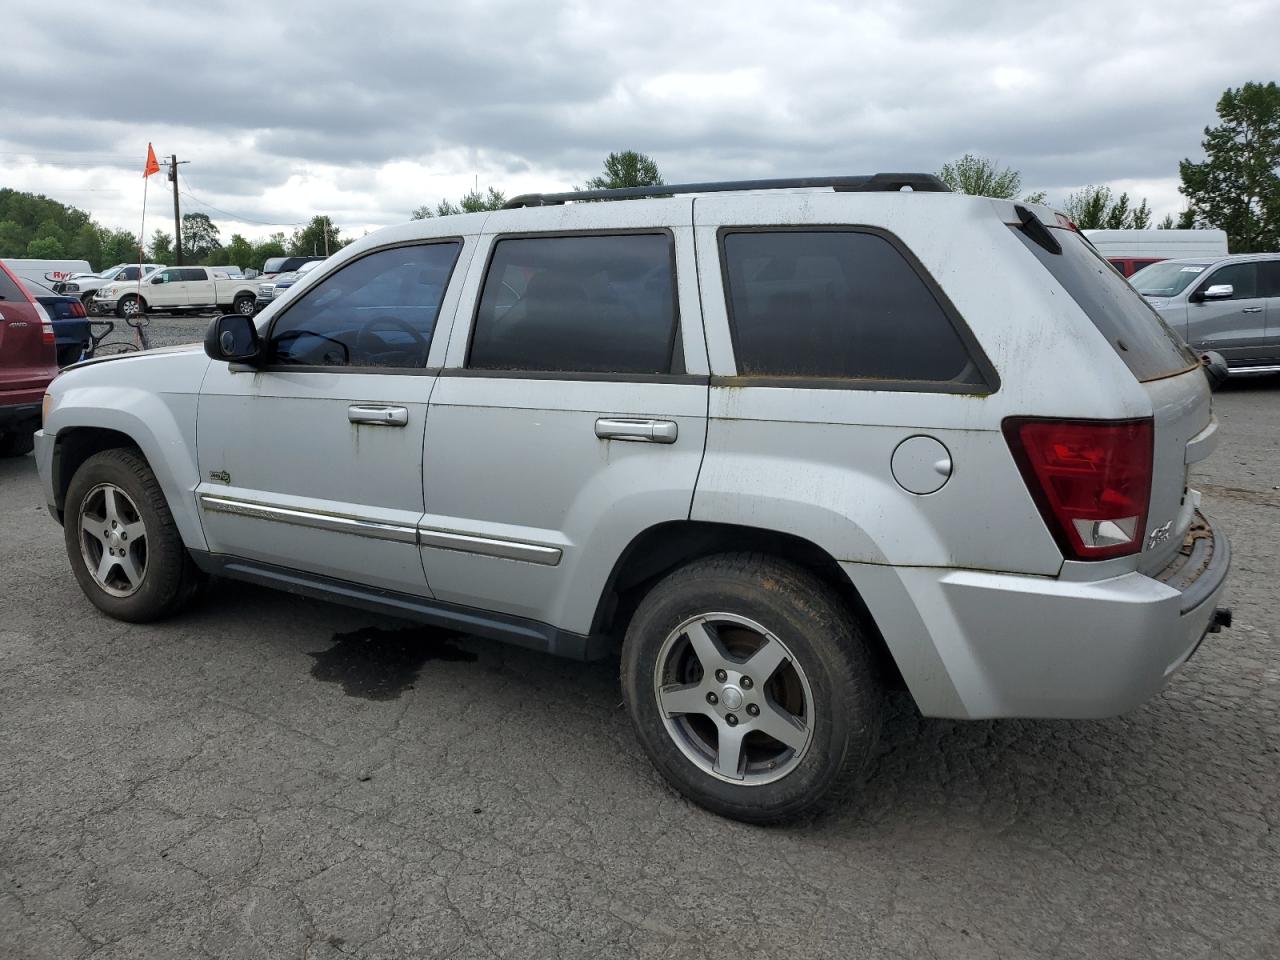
<box><xmin>30</xmin><ymin>174</ymin><xmax>1229</xmax><ymax>822</ymax></box>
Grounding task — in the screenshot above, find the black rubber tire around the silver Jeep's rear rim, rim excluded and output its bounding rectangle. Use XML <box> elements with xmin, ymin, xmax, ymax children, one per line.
<box><xmin>622</xmin><ymin>564</ymin><xmax>881</xmax><ymax>823</ymax></box>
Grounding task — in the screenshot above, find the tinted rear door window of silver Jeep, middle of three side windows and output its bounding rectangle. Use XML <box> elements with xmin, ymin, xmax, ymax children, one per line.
<box><xmin>467</xmin><ymin>233</ymin><xmax>676</xmax><ymax>374</ymax></box>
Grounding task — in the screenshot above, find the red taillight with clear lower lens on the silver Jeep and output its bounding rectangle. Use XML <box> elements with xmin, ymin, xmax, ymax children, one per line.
<box><xmin>1005</xmin><ymin>417</ymin><xmax>1155</xmax><ymax>559</ymax></box>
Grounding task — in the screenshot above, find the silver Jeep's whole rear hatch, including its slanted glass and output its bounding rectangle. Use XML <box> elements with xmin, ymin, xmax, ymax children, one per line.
<box><xmin>1014</xmin><ymin>218</ymin><xmax>1217</xmax><ymax>573</ymax></box>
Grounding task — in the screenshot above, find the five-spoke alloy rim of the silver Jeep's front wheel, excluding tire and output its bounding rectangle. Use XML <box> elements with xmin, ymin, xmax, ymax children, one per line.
<box><xmin>79</xmin><ymin>484</ymin><xmax>147</xmax><ymax>596</ymax></box>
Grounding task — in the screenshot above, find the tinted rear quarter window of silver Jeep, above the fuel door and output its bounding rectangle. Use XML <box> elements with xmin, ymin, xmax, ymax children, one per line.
<box><xmin>722</xmin><ymin>230</ymin><xmax>984</xmax><ymax>385</ymax></box>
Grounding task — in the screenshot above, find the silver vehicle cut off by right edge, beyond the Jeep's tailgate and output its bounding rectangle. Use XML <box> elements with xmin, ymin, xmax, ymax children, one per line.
<box><xmin>1130</xmin><ymin>253</ymin><xmax>1280</xmax><ymax>375</ymax></box>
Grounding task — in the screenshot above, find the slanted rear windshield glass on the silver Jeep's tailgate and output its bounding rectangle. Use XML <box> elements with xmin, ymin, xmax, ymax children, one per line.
<box><xmin>1012</xmin><ymin>227</ymin><xmax>1197</xmax><ymax>380</ymax></box>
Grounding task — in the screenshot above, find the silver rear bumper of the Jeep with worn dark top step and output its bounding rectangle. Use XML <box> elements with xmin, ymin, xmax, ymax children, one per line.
<box><xmin>851</xmin><ymin>516</ymin><xmax>1231</xmax><ymax>719</ymax></box>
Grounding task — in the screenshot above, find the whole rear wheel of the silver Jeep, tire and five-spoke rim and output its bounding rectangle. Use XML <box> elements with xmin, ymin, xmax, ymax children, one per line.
<box><xmin>622</xmin><ymin>554</ymin><xmax>883</xmax><ymax>823</ymax></box>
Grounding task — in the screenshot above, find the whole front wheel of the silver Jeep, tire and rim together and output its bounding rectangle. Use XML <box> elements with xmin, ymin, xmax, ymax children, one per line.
<box><xmin>63</xmin><ymin>449</ymin><xmax>202</xmax><ymax>623</ymax></box>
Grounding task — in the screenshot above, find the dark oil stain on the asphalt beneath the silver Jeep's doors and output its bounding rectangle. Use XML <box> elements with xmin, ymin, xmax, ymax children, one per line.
<box><xmin>307</xmin><ymin>627</ymin><xmax>476</xmax><ymax>700</ymax></box>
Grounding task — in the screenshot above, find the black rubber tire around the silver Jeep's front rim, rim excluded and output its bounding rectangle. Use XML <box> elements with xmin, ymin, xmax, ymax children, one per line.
<box><xmin>63</xmin><ymin>449</ymin><xmax>189</xmax><ymax>622</ymax></box>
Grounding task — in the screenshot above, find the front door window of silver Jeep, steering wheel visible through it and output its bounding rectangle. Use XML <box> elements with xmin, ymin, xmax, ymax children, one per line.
<box><xmin>269</xmin><ymin>241</ymin><xmax>462</xmax><ymax>367</ymax></box>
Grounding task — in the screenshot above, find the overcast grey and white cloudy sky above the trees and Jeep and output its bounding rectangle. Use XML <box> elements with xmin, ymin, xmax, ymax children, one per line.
<box><xmin>0</xmin><ymin>0</ymin><xmax>1280</xmax><ymax>238</ymax></box>
